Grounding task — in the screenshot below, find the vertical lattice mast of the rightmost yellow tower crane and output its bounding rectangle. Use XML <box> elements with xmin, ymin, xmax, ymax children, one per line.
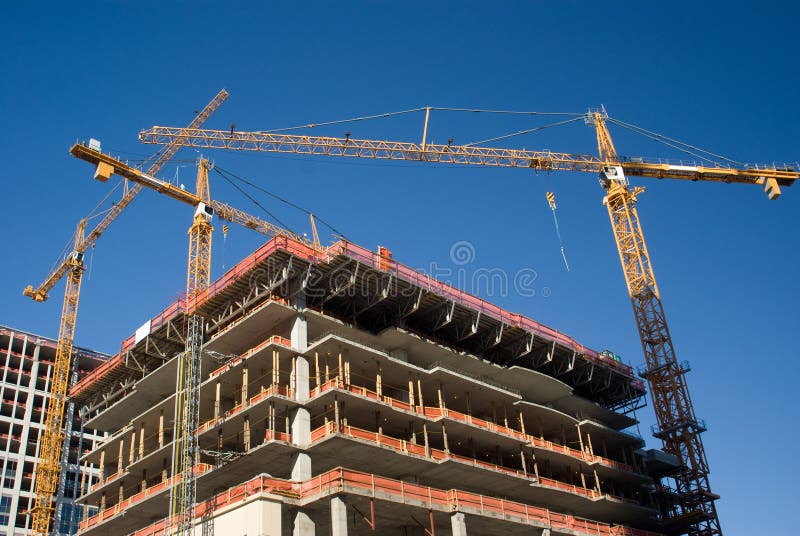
<box><xmin>590</xmin><ymin>112</ymin><xmax>722</xmax><ymax>536</ymax></box>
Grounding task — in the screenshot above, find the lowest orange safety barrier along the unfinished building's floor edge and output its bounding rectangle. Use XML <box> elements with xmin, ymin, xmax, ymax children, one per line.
<box><xmin>115</xmin><ymin>467</ymin><xmax>658</xmax><ymax>536</ymax></box>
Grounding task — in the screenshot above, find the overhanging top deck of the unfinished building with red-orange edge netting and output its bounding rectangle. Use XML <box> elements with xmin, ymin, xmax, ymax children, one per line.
<box><xmin>70</xmin><ymin>236</ymin><xmax>645</xmax><ymax>411</ymax></box>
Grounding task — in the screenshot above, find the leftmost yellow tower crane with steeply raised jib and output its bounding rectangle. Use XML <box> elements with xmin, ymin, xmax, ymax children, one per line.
<box><xmin>23</xmin><ymin>89</ymin><xmax>228</xmax><ymax>536</ymax></box>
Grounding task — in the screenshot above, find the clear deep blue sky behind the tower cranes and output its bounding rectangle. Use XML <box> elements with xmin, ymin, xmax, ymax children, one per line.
<box><xmin>0</xmin><ymin>1</ymin><xmax>800</xmax><ymax>535</ymax></box>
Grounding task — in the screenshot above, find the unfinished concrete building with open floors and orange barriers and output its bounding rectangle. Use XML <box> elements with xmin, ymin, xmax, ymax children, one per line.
<box><xmin>70</xmin><ymin>236</ymin><xmax>677</xmax><ymax>536</ymax></box>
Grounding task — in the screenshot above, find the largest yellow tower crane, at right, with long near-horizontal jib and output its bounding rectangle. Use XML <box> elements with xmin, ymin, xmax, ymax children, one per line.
<box><xmin>139</xmin><ymin>108</ymin><xmax>800</xmax><ymax>536</ymax></box>
